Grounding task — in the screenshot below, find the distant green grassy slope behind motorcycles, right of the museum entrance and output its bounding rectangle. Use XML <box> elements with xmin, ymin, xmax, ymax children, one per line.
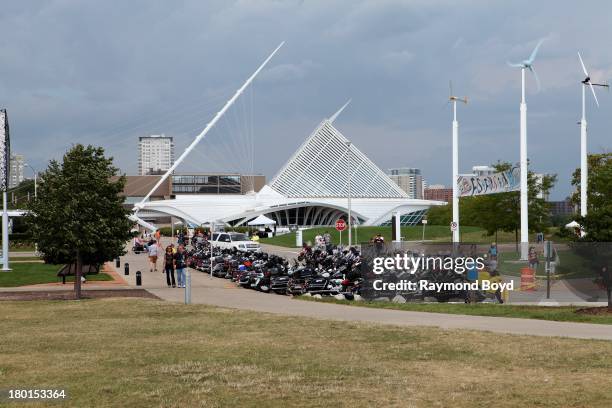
<box><xmin>261</xmin><ymin>225</ymin><xmax>552</xmax><ymax>248</ymax></box>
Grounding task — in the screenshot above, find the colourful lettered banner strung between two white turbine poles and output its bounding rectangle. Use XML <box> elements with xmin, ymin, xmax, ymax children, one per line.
<box><xmin>457</xmin><ymin>166</ymin><xmax>521</xmax><ymax>197</ymax></box>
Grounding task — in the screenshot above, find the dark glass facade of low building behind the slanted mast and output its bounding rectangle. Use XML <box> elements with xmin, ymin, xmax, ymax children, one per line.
<box><xmin>172</xmin><ymin>174</ymin><xmax>242</xmax><ymax>194</ymax></box>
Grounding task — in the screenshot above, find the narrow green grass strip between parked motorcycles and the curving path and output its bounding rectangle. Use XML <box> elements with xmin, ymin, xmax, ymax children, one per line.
<box><xmin>300</xmin><ymin>296</ymin><xmax>612</xmax><ymax>324</ymax></box>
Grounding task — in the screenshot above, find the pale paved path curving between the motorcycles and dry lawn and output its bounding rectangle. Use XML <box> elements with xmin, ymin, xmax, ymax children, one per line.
<box><xmin>120</xmin><ymin>245</ymin><xmax>612</xmax><ymax>340</ymax></box>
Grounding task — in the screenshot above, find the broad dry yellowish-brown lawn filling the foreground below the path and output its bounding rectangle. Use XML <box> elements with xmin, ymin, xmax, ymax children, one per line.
<box><xmin>0</xmin><ymin>299</ymin><xmax>612</xmax><ymax>408</ymax></box>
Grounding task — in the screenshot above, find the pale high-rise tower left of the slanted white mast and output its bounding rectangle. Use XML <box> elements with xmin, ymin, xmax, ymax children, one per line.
<box><xmin>138</xmin><ymin>134</ymin><xmax>174</xmax><ymax>176</ymax></box>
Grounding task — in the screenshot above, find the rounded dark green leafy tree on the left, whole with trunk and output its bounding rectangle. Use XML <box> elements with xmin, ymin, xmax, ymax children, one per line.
<box><xmin>25</xmin><ymin>144</ymin><xmax>132</xmax><ymax>299</ymax></box>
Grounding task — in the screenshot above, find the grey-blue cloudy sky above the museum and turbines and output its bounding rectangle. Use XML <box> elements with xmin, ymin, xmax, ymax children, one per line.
<box><xmin>0</xmin><ymin>0</ymin><xmax>612</xmax><ymax>199</ymax></box>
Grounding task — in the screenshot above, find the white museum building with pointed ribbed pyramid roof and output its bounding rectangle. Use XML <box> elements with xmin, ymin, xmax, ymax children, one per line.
<box><xmin>137</xmin><ymin>118</ymin><xmax>446</xmax><ymax>227</ymax></box>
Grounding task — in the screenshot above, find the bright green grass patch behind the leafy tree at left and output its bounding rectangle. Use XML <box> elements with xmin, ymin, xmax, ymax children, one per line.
<box><xmin>0</xmin><ymin>262</ymin><xmax>113</xmax><ymax>288</ymax></box>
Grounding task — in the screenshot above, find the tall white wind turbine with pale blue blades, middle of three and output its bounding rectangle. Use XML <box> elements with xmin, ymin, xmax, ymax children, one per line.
<box><xmin>508</xmin><ymin>40</ymin><xmax>543</xmax><ymax>260</ymax></box>
